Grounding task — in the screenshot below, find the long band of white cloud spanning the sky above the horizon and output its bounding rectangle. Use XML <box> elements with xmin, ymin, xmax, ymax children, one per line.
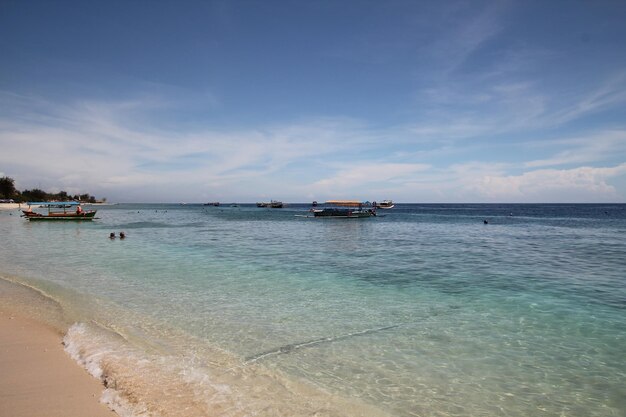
<box><xmin>0</xmin><ymin>89</ymin><xmax>626</xmax><ymax>202</ymax></box>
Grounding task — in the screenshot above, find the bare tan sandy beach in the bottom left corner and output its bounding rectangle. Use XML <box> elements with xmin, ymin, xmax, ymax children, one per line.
<box><xmin>0</xmin><ymin>307</ymin><xmax>117</xmax><ymax>417</ymax></box>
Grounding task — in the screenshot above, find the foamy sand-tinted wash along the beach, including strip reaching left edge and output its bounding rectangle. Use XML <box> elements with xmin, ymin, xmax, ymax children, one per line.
<box><xmin>0</xmin><ymin>274</ymin><xmax>389</xmax><ymax>417</ymax></box>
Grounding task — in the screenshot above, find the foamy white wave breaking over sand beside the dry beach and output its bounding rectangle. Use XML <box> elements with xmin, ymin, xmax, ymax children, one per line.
<box><xmin>63</xmin><ymin>323</ymin><xmax>386</xmax><ymax>417</ymax></box>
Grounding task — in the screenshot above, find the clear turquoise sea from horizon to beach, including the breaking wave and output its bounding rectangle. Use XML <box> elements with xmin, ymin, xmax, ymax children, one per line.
<box><xmin>0</xmin><ymin>204</ymin><xmax>626</xmax><ymax>417</ymax></box>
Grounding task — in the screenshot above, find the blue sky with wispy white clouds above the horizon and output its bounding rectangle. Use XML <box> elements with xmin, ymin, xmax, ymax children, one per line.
<box><xmin>0</xmin><ymin>0</ymin><xmax>626</xmax><ymax>203</ymax></box>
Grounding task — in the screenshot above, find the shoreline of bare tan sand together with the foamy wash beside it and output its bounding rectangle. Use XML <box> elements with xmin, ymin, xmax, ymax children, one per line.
<box><xmin>0</xmin><ymin>272</ymin><xmax>390</xmax><ymax>417</ymax></box>
